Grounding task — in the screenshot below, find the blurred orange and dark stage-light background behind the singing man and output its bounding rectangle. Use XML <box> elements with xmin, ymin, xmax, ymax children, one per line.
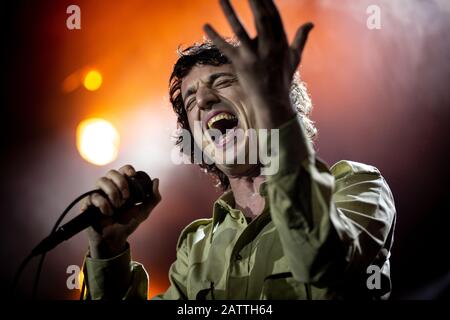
<box><xmin>0</xmin><ymin>0</ymin><xmax>450</xmax><ymax>299</ymax></box>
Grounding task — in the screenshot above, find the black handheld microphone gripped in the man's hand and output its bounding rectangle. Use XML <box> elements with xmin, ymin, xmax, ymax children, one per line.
<box><xmin>31</xmin><ymin>171</ymin><xmax>153</xmax><ymax>256</ymax></box>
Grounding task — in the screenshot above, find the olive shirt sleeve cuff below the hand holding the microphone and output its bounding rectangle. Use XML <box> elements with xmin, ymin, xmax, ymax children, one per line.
<box><xmin>83</xmin><ymin>247</ymin><xmax>148</xmax><ymax>300</ymax></box>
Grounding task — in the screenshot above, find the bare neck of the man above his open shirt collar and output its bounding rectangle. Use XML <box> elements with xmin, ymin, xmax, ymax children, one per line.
<box><xmin>228</xmin><ymin>175</ymin><xmax>265</xmax><ymax>218</ymax></box>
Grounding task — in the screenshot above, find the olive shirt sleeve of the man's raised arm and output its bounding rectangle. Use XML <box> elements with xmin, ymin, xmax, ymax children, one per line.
<box><xmin>264</xmin><ymin>117</ymin><xmax>395</xmax><ymax>286</ymax></box>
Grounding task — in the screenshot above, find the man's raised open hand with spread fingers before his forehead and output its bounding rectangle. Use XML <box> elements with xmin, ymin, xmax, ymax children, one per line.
<box><xmin>204</xmin><ymin>0</ymin><xmax>313</xmax><ymax>128</ymax></box>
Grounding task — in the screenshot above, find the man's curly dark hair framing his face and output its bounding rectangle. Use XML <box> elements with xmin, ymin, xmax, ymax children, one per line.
<box><xmin>169</xmin><ymin>39</ymin><xmax>317</xmax><ymax>190</ymax></box>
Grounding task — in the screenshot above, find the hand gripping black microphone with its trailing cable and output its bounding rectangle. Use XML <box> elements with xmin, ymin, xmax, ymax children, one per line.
<box><xmin>11</xmin><ymin>165</ymin><xmax>161</xmax><ymax>297</ymax></box>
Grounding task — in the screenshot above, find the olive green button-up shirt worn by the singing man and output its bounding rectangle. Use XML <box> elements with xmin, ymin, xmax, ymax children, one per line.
<box><xmin>84</xmin><ymin>118</ymin><xmax>396</xmax><ymax>299</ymax></box>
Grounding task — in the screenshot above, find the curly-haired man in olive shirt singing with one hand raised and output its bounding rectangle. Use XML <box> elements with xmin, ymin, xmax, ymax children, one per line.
<box><xmin>79</xmin><ymin>0</ymin><xmax>396</xmax><ymax>299</ymax></box>
